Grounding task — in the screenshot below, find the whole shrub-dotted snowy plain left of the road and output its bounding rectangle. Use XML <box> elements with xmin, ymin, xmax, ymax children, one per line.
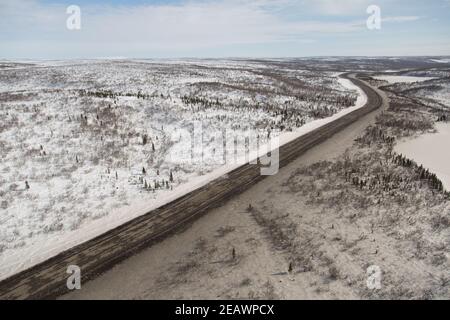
<box><xmin>0</xmin><ymin>60</ymin><xmax>365</xmax><ymax>278</ymax></box>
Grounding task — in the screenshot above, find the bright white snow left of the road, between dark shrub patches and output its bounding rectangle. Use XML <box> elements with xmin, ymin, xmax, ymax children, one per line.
<box><xmin>0</xmin><ymin>61</ymin><xmax>367</xmax><ymax>279</ymax></box>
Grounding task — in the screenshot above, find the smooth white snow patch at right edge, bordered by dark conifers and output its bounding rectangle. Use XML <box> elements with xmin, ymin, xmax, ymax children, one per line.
<box><xmin>395</xmin><ymin>122</ymin><xmax>450</xmax><ymax>191</ymax></box>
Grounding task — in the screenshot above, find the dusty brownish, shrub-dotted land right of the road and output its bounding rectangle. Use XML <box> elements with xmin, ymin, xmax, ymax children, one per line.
<box><xmin>62</xmin><ymin>60</ymin><xmax>450</xmax><ymax>300</ymax></box>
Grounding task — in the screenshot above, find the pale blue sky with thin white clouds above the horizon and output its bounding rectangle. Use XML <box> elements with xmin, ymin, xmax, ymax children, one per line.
<box><xmin>0</xmin><ymin>0</ymin><xmax>450</xmax><ymax>59</ymax></box>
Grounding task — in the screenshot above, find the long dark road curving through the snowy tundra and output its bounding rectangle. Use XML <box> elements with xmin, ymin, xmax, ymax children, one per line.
<box><xmin>0</xmin><ymin>74</ymin><xmax>386</xmax><ymax>299</ymax></box>
